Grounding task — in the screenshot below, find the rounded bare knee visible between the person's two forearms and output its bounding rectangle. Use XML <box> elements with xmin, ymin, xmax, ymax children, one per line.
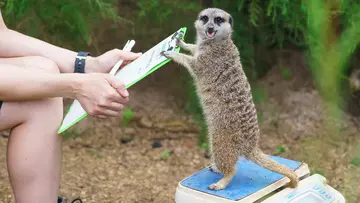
<box><xmin>26</xmin><ymin>56</ymin><xmax>60</xmax><ymax>74</ymax></box>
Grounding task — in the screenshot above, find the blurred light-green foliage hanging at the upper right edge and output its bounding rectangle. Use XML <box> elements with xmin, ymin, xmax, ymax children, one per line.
<box><xmin>305</xmin><ymin>0</ymin><xmax>360</xmax><ymax>111</ymax></box>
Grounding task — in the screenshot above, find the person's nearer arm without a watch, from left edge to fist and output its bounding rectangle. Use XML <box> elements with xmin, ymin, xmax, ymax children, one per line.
<box><xmin>0</xmin><ymin>64</ymin><xmax>129</xmax><ymax>118</ymax></box>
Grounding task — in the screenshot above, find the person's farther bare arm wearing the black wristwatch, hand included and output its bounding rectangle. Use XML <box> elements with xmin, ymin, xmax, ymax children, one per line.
<box><xmin>0</xmin><ymin>11</ymin><xmax>140</xmax><ymax>73</ymax></box>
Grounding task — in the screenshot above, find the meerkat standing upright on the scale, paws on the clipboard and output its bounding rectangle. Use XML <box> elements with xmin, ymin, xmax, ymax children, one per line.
<box><xmin>162</xmin><ymin>8</ymin><xmax>298</xmax><ymax>190</ymax></box>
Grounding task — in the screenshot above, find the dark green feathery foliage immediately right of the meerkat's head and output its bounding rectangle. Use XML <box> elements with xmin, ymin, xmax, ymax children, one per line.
<box><xmin>213</xmin><ymin>0</ymin><xmax>306</xmax><ymax>80</ymax></box>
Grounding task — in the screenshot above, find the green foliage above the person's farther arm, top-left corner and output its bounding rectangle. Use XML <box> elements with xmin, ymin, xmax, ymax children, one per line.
<box><xmin>0</xmin><ymin>0</ymin><xmax>120</xmax><ymax>46</ymax></box>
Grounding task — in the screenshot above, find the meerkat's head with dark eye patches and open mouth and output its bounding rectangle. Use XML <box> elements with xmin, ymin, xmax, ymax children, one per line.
<box><xmin>195</xmin><ymin>8</ymin><xmax>233</xmax><ymax>40</ymax></box>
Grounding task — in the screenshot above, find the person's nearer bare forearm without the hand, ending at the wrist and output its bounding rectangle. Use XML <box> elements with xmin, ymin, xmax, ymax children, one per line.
<box><xmin>0</xmin><ymin>65</ymin><xmax>78</xmax><ymax>101</ymax></box>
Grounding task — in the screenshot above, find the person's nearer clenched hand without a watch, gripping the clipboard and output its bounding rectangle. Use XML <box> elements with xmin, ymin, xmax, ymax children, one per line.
<box><xmin>75</xmin><ymin>73</ymin><xmax>129</xmax><ymax>118</ymax></box>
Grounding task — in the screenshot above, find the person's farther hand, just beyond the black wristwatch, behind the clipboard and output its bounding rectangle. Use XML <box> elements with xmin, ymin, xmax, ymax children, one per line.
<box><xmin>85</xmin><ymin>49</ymin><xmax>141</xmax><ymax>73</ymax></box>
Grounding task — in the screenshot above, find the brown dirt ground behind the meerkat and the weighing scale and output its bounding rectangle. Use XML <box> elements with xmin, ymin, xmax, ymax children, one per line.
<box><xmin>0</xmin><ymin>49</ymin><xmax>360</xmax><ymax>203</ymax></box>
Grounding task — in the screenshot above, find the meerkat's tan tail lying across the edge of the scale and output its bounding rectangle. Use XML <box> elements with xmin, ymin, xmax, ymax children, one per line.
<box><xmin>247</xmin><ymin>148</ymin><xmax>299</xmax><ymax>188</ymax></box>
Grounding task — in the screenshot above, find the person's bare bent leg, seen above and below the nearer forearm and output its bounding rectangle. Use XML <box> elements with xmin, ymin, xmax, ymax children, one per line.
<box><xmin>0</xmin><ymin>57</ymin><xmax>63</xmax><ymax>203</ymax></box>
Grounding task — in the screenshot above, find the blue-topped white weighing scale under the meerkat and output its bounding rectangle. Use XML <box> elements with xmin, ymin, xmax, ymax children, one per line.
<box><xmin>175</xmin><ymin>156</ymin><xmax>345</xmax><ymax>203</ymax></box>
